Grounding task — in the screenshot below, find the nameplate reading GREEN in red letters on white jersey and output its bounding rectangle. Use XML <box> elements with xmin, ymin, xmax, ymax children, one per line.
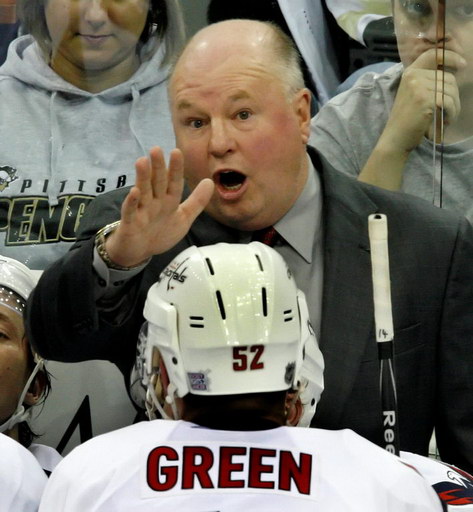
<box><xmin>141</xmin><ymin>442</ymin><xmax>315</xmax><ymax>500</ymax></box>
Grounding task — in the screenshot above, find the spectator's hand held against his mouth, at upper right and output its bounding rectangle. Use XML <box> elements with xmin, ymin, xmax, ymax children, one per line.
<box><xmin>382</xmin><ymin>48</ymin><xmax>466</xmax><ymax>153</ymax></box>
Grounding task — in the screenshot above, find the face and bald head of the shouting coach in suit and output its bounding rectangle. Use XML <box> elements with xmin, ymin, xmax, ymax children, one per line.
<box><xmin>170</xmin><ymin>21</ymin><xmax>310</xmax><ymax>230</ymax></box>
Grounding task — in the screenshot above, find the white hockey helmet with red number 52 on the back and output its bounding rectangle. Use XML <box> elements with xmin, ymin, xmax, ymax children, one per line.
<box><xmin>142</xmin><ymin>242</ymin><xmax>323</xmax><ymax>425</ymax></box>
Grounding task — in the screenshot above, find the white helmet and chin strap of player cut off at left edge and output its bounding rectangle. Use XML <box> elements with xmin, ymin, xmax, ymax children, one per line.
<box><xmin>0</xmin><ymin>255</ymin><xmax>44</xmax><ymax>432</ymax></box>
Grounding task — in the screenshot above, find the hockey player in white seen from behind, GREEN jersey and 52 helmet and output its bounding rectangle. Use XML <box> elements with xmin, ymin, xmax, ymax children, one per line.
<box><xmin>40</xmin><ymin>242</ymin><xmax>441</xmax><ymax>512</ymax></box>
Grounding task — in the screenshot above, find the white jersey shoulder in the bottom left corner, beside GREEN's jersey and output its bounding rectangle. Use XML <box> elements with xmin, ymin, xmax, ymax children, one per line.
<box><xmin>0</xmin><ymin>434</ymin><xmax>47</xmax><ymax>512</ymax></box>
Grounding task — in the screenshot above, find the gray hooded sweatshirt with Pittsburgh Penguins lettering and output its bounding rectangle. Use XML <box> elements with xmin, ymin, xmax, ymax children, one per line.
<box><xmin>0</xmin><ymin>35</ymin><xmax>175</xmax><ymax>269</ymax></box>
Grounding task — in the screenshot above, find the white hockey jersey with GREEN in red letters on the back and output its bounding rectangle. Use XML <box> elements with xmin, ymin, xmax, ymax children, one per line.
<box><xmin>40</xmin><ymin>420</ymin><xmax>442</xmax><ymax>512</ymax></box>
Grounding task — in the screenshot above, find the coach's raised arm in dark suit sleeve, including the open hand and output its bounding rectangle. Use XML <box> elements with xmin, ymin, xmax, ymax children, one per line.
<box><xmin>27</xmin><ymin>148</ymin><xmax>213</xmax><ymax>374</ymax></box>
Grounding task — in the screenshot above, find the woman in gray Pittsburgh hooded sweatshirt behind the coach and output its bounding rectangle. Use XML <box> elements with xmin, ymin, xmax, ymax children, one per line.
<box><xmin>0</xmin><ymin>0</ymin><xmax>184</xmax><ymax>269</ymax></box>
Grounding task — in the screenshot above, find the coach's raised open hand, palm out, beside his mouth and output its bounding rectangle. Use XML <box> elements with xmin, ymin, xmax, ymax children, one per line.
<box><xmin>105</xmin><ymin>147</ymin><xmax>214</xmax><ymax>267</ymax></box>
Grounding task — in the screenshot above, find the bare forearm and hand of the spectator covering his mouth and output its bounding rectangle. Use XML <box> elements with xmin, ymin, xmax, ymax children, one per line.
<box><xmin>358</xmin><ymin>49</ymin><xmax>460</xmax><ymax>190</ymax></box>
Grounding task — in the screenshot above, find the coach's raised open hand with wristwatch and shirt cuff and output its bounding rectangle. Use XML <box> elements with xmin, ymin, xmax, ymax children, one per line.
<box><xmin>89</xmin><ymin>147</ymin><xmax>213</xmax><ymax>310</ymax></box>
